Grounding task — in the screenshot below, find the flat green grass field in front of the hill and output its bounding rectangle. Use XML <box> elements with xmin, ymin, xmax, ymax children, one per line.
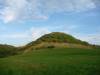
<box><xmin>0</xmin><ymin>48</ymin><xmax>100</xmax><ymax>75</ymax></box>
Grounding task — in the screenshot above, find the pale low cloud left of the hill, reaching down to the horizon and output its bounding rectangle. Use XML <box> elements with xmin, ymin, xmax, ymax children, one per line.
<box><xmin>0</xmin><ymin>27</ymin><xmax>50</xmax><ymax>46</ymax></box>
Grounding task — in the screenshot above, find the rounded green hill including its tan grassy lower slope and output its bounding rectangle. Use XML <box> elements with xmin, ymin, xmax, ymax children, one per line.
<box><xmin>23</xmin><ymin>32</ymin><xmax>90</xmax><ymax>49</ymax></box>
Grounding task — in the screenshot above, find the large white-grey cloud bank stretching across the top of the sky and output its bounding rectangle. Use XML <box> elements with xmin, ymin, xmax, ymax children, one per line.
<box><xmin>0</xmin><ymin>0</ymin><xmax>100</xmax><ymax>23</ymax></box>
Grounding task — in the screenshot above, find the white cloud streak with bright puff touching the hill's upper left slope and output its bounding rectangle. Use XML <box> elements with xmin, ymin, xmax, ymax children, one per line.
<box><xmin>0</xmin><ymin>27</ymin><xmax>50</xmax><ymax>40</ymax></box>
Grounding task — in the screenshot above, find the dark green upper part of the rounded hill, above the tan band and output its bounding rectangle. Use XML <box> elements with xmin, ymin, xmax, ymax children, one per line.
<box><xmin>29</xmin><ymin>32</ymin><xmax>88</xmax><ymax>45</ymax></box>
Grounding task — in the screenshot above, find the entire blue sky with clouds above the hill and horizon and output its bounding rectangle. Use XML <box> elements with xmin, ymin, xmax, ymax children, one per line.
<box><xmin>0</xmin><ymin>0</ymin><xmax>100</xmax><ymax>46</ymax></box>
